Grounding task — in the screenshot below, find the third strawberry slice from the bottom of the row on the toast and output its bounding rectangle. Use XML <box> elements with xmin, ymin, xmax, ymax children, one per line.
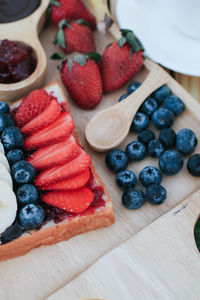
<box><xmin>35</xmin><ymin>149</ymin><xmax>91</xmax><ymax>187</ymax></box>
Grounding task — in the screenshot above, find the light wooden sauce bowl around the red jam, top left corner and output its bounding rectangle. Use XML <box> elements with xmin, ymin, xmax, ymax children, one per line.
<box><xmin>0</xmin><ymin>0</ymin><xmax>50</xmax><ymax>101</ymax></box>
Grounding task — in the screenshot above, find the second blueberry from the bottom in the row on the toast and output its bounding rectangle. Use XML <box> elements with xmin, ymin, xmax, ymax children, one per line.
<box><xmin>16</xmin><ymin>183</ymin><xmax>39</xmax><ymax>205</ymax></box>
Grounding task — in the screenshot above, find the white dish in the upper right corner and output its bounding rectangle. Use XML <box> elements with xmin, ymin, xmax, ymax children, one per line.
<box><xmin>116</xmin><ymin>0</ymin><xmax>200</xmax><ymax>76</ymax></box>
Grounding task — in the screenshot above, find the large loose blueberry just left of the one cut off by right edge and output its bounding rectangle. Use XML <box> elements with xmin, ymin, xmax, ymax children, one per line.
<box><xmin>159</xmin><ymin>150</ymin><xmax>183</xmax><ymax>176</ymax></box>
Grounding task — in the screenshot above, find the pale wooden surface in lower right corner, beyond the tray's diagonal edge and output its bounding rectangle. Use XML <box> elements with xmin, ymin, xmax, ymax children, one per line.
<box><xmin>47</xmin><ymin>190</ymin><xmax>200</xmax><ymax>300</ymax></box>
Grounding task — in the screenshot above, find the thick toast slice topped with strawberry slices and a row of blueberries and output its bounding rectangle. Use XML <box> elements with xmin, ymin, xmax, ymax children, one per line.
<box><xmin>0</xmin><ymin>83</ymin><xmax>114</xmax><ymax>261</ymax></box>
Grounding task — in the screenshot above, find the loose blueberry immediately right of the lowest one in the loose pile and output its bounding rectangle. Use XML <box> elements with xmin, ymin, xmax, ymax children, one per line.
<box><xmin>145</xmin><ymin>184</ymin><xmax>167</xmax><ymax>205</ymax></box>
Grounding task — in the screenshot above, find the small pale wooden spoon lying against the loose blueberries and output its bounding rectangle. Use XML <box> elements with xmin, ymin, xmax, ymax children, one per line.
<box><xmin>85</xmin><ymin>62</ymin><xmax>169</xmax><ymax>152</ymax></box>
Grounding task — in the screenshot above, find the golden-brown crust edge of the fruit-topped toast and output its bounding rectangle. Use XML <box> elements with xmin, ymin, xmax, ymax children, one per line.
<box><xmin>0</xmin><ymin>81</ymin><xmax>115</xmax><ymax>261</ymax></box>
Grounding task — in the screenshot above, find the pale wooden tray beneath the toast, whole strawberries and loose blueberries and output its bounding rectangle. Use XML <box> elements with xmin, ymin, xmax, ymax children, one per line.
<box><xmin>0</xmin><ymin>17</ymin><xmax>200</xmax><ymax>300</ymax></box>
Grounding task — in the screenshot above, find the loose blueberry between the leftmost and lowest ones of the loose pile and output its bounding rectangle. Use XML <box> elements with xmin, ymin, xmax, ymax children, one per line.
<box><xmin>115</xmin><ymin>170</ymin><xmax>137</xmax><ymax>190</ymax></box>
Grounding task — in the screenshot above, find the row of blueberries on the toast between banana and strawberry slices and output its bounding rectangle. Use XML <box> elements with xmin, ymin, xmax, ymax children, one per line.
<box><xmin>0</xmin><ymin>101</ymin><xmax>45</xmax><ymax>242</ymax></box>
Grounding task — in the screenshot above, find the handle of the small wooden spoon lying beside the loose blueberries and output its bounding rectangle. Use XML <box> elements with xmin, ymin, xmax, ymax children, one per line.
<box><xmin>115</xmin><ymin>59</ymin><xmax>170</xmax><ymax>120</ymax></box>
